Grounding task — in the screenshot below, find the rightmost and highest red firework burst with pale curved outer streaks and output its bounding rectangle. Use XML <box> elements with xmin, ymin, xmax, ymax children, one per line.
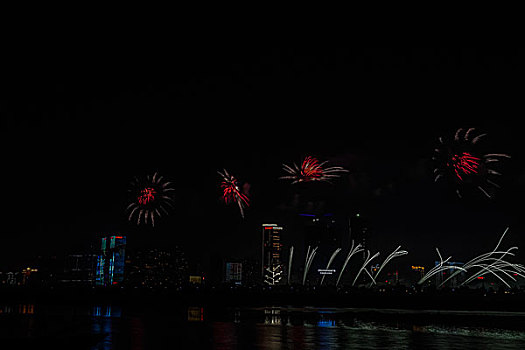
<box><xmin>432</xmin><ymin>128</ymin><xmax>510</xmax><ymax>198</ymax></box>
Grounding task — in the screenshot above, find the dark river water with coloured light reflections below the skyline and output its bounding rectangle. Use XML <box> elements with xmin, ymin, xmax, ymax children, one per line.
<box><xmin>0</xmin><ymin>304</ymin><xmax>525</xmax><ymax>350</ymax></box>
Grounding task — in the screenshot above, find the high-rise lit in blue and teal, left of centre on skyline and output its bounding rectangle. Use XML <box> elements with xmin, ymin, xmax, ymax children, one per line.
<box><xmin>95</xmin><ymin>236</ymin><xmax>126</xmax><ymax>286</ymax></box>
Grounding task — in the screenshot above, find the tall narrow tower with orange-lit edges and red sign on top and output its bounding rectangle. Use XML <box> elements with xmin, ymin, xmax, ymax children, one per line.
<box><xmin>261</xmin><ymin>224</ymin><xmax>283</xmax><ymax>285</ymax></box>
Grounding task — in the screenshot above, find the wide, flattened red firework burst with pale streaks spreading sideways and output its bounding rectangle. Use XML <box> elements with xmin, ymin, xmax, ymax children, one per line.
<box><xmin>280</xmin><ymin>156</ymin><xmax>348</xmax><ymax>184</ymax></box>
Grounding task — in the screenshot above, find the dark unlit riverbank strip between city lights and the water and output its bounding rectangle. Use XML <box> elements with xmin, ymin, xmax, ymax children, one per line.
<box><xmin>4</xmin><ymin>288</ymin><xmax>525</xmax><ymax>312</ymax></box>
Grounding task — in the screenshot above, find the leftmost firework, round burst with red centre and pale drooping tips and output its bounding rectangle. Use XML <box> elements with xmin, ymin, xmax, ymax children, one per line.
<box><xmin>126</xmin><ymin>173</ymin><xmax>175</xmax><ymax>226</ymax></box>
